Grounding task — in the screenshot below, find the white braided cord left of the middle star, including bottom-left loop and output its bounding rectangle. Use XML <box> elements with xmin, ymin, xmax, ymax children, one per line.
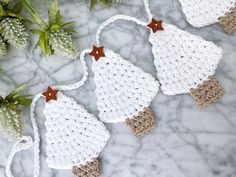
<box><xmin>6</xmin><ymin>49</ymin><xmax>90</xmax><ymax>177</ymax></box>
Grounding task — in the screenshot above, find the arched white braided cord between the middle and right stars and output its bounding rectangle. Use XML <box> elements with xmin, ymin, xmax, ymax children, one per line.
<box><xmin>96</xmin><ymin>15</ymin><xmax>147</xmax><ymax>46</ymax></box>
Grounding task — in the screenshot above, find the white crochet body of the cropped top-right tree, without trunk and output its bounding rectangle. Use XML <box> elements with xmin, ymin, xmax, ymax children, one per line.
<box><xmin>179</xmin><ymin>0</ymin><xmax>236</xmax><ymax>28</ymax></box>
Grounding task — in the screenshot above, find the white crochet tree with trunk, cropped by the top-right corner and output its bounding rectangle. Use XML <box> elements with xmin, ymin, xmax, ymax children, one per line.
<box><xmin>179</xmin><ymin>0</ymin><xmax>236</xmax><ymax>33</ymax></box>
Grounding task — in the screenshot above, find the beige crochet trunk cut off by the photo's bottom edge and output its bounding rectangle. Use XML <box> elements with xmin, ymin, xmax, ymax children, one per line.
<box><xmin>73</xmin><ymin>159</ymin><xmax>101</xmax><ymax>177</ymax></box>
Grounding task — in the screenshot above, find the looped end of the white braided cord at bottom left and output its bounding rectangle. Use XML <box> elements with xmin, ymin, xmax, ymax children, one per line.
<box><xmin>5</xmin><ymin>136</ymin><xmax>33</xmax><ymax>177</ymax></box>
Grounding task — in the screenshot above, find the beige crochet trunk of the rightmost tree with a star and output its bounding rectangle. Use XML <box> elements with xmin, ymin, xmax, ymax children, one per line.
<box><xmin>190</xmin><ymin>77</ymin><xmax>224</xmax><ymax>107</ymax></box>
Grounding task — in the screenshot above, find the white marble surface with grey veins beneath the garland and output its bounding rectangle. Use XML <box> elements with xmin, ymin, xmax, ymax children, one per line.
<box><xmin>0</xmin><ymin>0</ymin><xmax>236</xmax><ymax>177</ymax></box>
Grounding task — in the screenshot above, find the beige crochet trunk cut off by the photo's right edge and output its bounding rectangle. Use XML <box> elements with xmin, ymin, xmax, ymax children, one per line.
<box><xmin>219</xmin><ymin>5</ymin><xmax>236</xmax><ymax>33</ymax></box>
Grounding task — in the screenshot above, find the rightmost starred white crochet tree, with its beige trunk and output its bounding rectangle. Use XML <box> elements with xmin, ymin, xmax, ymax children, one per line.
<box><xmin>149</xmin><ymin>19</ymin><xmax>224</xmax><ymax>106</ymax></box>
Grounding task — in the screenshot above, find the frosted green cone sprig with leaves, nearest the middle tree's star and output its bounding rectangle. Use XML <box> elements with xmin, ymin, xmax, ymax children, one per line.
<box><xmin>24</xmin><ymin>0</ymin><xmax>76</xmax><ymax>58</ymax></box>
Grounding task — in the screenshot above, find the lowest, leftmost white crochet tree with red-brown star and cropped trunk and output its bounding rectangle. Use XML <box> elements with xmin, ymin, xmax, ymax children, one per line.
<box><xmin>43</xmin><ymin>88</ymin><xmax>109</xmax><ymax>177</ymax></box>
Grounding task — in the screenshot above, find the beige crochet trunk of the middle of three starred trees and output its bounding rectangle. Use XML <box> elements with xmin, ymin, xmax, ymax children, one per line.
<box><xmin>126</xmin><ymin>108</ymin><xmax>155</xmax><ymax>136</ymax></box>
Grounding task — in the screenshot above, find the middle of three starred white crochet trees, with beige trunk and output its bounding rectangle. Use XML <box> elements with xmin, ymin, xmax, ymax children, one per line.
<box><xmin>90</xmin><ymin>46</ymin><xmax>159</xmax><ymax>136</ymax></box>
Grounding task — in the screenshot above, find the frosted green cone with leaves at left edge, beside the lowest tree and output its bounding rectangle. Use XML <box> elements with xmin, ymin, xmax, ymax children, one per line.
<box><xmin>0</xmin><ymin>84</ymin><xmax>32</xmax><ymax>140</ymax></box>
